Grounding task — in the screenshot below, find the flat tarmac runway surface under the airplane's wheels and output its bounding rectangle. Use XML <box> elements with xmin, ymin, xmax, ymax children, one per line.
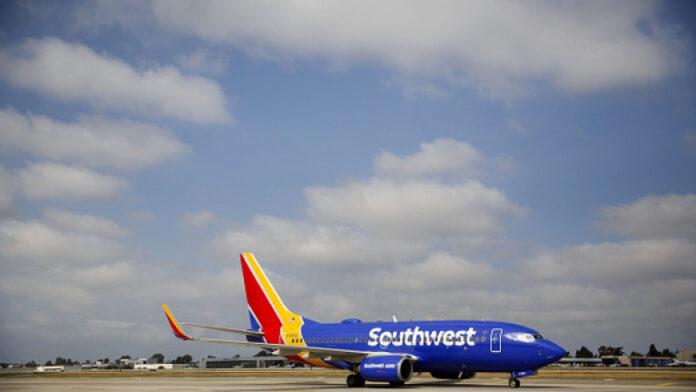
<box><xmin>0</xmin><ymin>377</ymin><xmax>696</xmax><ymax>392</ymax></box>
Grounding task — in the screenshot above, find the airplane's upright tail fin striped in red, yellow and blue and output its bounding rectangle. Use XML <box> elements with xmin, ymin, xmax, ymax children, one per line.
<box><xmin>240</xmin><ymin>252</ymin><xmax>303</xmax><ymax>344</ymax></box>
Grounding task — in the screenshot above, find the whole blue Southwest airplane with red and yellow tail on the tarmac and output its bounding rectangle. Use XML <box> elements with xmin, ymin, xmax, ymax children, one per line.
<box><xmin>162</xmin><ymin>252</ymin><xmax>565</xmax><ymax>388</ymax></box>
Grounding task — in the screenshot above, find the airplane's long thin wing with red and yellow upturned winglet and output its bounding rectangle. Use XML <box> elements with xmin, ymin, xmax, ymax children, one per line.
<box><xmin>162</xmin><ymin>304</ymin><xmax>418</xmax><ymax>363</ymax></box>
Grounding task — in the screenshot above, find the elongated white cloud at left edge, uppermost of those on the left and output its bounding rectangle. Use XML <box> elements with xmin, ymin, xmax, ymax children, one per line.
<box><xmin>0</xmin><ymin>38</ymin><xmax>232</xmax><ymax>123</ymax></box>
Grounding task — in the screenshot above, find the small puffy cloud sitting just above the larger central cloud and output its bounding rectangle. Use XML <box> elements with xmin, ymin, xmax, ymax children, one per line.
<box><xmin>375</xmin><ymin>138</ymin><xmax>486</xmax><ymax>178</ymax></box>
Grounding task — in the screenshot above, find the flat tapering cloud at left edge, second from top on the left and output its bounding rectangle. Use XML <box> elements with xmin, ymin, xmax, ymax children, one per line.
<box><xmin>0</xmin><ymin>109</ymin><xmax>189</xmax><ymax>169</ymax></box>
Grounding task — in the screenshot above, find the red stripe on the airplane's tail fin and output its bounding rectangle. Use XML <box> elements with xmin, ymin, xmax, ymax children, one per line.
<box><xmin>240</xmin><ymin>256</ymin><xmax>283</xmax><ymax>343</ymax></box>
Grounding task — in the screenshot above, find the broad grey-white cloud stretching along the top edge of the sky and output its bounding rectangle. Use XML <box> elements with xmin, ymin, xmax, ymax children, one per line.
<box><xmin>154</xmin><ymin>0</ymin><xmax>684</xmax><ymax>95</ymax></box>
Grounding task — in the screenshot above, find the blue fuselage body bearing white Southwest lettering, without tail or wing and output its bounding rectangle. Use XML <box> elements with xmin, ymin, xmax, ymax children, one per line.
<box><xmin>302</xmin><ymin>320</ymin><xmax>565</xmax><ymax>372</ymax></box>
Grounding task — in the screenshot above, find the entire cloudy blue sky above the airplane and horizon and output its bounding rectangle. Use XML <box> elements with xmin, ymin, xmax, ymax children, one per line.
<box><xmin>0</xmin><ymin>0</ymin><xmax>696</xmax><ymax>362</ymax></box>
